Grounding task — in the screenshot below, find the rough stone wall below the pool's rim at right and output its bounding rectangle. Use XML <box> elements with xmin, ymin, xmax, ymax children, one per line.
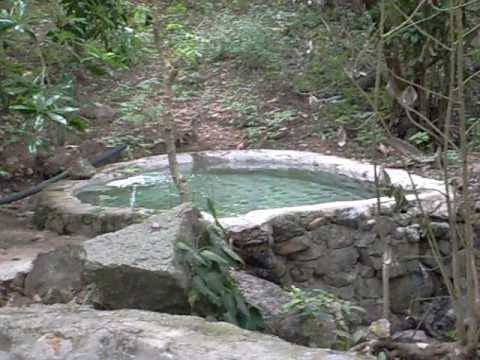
<box><xmin>230</xmin><ymin>208</ymin><xmax>450</xmax><ymax>313</ymax></box>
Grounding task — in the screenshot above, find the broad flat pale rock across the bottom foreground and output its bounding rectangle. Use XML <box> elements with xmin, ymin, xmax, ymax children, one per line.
<box><xmin>0</xmin><ymin>305</ymin><xmax>367</xmax><ymax>360</ymax></box>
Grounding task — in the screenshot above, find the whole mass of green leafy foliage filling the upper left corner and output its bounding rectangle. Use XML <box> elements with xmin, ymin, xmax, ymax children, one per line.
<box><xmin>0</xmin><ymin>0</ymin><xmax>149</xmax><ymax>151</ymax></box>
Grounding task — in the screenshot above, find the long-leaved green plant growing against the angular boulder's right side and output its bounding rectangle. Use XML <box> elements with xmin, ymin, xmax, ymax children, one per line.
<box><xmin>177</xmin><ymin>200</ymin><xmax>264</xmax><ymax>330</ymax></box>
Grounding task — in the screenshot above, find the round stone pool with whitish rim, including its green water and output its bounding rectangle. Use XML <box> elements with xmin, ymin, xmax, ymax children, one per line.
<box><xmin>34</xmin><ymin>150</ymin><xmax>444</xmax><ymax>236</ymax></box>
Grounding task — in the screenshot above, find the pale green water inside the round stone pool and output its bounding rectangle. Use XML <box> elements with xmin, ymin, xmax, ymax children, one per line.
<box><xmin>77</xmin><ymin>169</ymin><xmax>375</xmax><ymax>216</ymax></box>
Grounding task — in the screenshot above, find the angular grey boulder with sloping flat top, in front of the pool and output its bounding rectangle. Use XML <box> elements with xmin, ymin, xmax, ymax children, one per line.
<box><xmin>26</xmin><ymin>204</ymin><xmax>201</xmax><ymax>314</ymax></box>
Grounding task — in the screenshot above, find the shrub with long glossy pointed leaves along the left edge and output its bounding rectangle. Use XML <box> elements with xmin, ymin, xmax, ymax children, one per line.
<box><xmin>0</xmin><ymin>0</ymin><xmax>86</xmax><ymax>152</ymax></box>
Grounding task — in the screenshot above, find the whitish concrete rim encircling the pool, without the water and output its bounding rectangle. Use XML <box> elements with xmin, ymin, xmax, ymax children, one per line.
<box><xmin>35</xmin><ymin>150</ymin><xmax>445</xmax><ymax>236</ymax></box>
